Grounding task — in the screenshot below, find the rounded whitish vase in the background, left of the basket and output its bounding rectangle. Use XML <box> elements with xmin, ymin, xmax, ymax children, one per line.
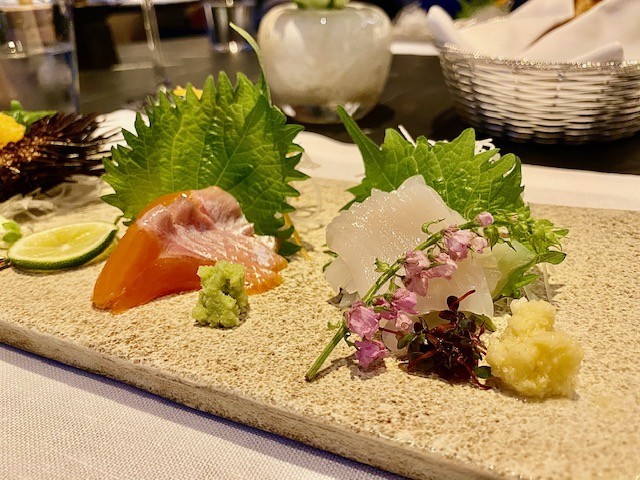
<box><xmin>258</xmin><ymin>3</ymin><xmax>391</xmax><ymax>123</ymax></box>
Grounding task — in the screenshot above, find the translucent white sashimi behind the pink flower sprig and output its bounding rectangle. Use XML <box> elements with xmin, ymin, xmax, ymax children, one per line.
<box><xmin>325</xmin><ymin>175</ymin><xmax>493</xmax><ymax>316</ymax></box>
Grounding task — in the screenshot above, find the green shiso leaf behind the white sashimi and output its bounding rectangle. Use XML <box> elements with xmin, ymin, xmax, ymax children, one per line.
<box><xmin>339</xmin><ymin>108</ymin><xmax>525</xmax><ymax>218</ymax></box>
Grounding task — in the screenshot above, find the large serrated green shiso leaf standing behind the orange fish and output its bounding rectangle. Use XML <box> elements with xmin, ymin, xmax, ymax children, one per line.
<box><xmin>104</xmin><ymin>72</ymin><xmax>307</xmax><ymax>249</ymax></box>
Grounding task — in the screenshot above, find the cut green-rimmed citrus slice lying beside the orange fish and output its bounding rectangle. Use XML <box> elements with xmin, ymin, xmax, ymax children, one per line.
<box><xmin>7</xmin><ymin>222</ymin><xmax>118</xmax><ymax>270</ymax></box>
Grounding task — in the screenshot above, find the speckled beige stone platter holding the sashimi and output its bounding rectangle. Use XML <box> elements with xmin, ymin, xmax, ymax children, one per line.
<box><xmin>0</xmin><ymin>182</ymin><xmax>640</xmax><ymax>479</ymax></box>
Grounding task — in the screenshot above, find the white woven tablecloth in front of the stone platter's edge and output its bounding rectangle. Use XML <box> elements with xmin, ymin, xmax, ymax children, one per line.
<box><xmin>0</xmin><ymin>344</ymin><xmax>399</xmax><ymax>480</ymax></box>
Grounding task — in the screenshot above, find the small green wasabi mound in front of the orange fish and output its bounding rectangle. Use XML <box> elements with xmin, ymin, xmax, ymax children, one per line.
<box><xmin>191</xmin><ymin>261</ymin><xmax>249</xmax><ymax>328</ymax></box>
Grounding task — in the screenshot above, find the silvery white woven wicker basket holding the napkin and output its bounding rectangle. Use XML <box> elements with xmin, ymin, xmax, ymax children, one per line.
<box><xmin>440</xmin><ymin>45</ymin><xmax>640</xmax><ymax>143</ymax></box>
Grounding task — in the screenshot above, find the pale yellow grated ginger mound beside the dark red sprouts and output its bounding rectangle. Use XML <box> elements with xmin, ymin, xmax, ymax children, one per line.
<box><xmin>485</xmin><ymin>300</ymin><xmax>584</xmax><ymax>398</ymax></box>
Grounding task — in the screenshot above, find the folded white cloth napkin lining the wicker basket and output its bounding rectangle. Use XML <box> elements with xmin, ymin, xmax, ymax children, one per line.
<box><xmin>427</xmin><ymin>0</ymin><xmax>640</xmax><ymax>62</ymax></box>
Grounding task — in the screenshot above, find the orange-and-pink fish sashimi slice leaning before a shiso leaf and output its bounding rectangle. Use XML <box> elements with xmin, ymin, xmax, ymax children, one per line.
<box><xmin>93</xmin><ymin>187</ymin><xmax>287</xmax><ymax>312</ymax></box>
